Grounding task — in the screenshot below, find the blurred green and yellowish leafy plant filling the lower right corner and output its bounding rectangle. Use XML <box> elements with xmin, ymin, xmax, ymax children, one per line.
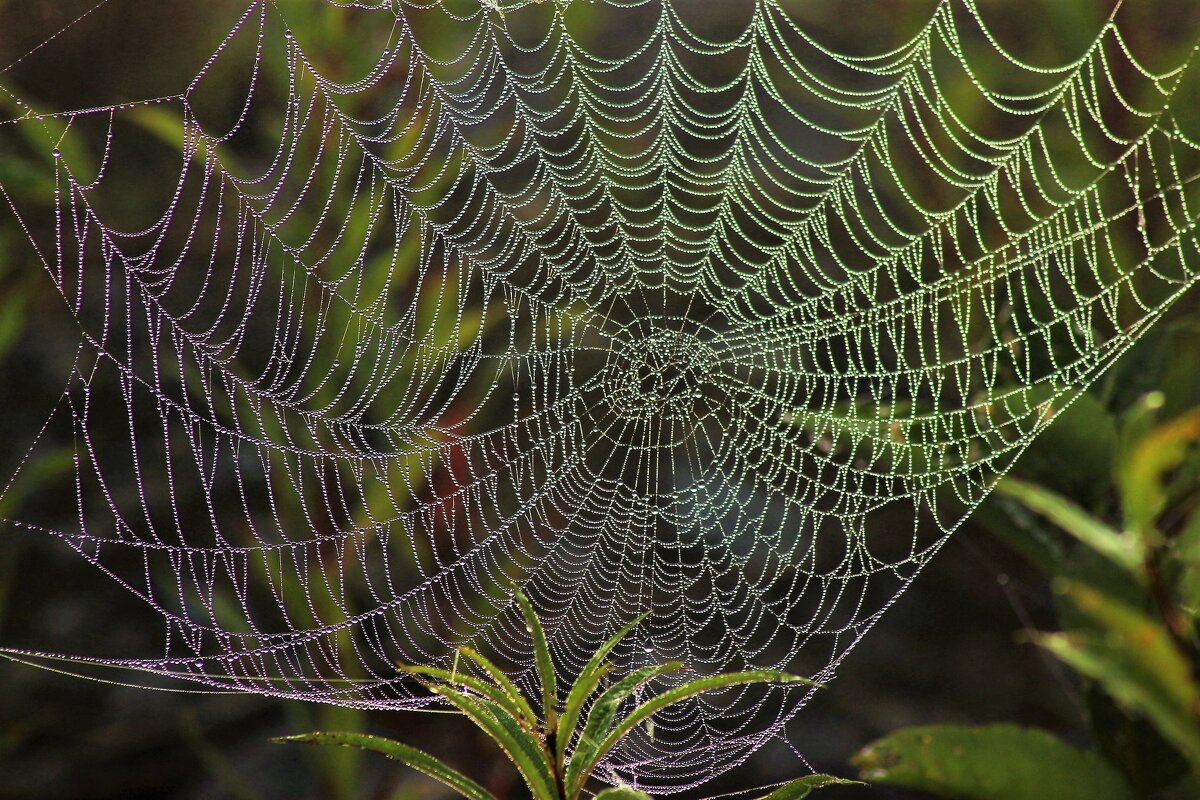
<box><xmin>854</xmin><ymin>381</ymin><xmax>1200</xmax><ymax>800</ymax></box>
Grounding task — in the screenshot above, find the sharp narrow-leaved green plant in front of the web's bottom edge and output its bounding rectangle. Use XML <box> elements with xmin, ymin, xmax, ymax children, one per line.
<box><xmin>276</xmin><ymin>593</ymin><xmax>854</xmax><ymax>800</ymax></box>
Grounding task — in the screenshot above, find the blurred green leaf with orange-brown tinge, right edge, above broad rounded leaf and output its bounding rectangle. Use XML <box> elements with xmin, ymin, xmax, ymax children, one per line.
<box><xmin>1037</xmin><ymin>583</ymin><xmax>1200</xmax><ymax>764</ymax></box>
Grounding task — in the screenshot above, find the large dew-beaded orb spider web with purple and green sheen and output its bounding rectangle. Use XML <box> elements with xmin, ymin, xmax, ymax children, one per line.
<box><xmin>0</xmin><ymin>0</ymin><xmax>1200</xmax><ymax>790</ymax></box>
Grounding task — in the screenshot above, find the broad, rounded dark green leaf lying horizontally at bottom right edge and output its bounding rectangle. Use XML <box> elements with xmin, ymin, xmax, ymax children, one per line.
<box><xmin>851</xmin><ymin>724</ymin><xmax>1132</xmax><ymax>800</ymax></box>
